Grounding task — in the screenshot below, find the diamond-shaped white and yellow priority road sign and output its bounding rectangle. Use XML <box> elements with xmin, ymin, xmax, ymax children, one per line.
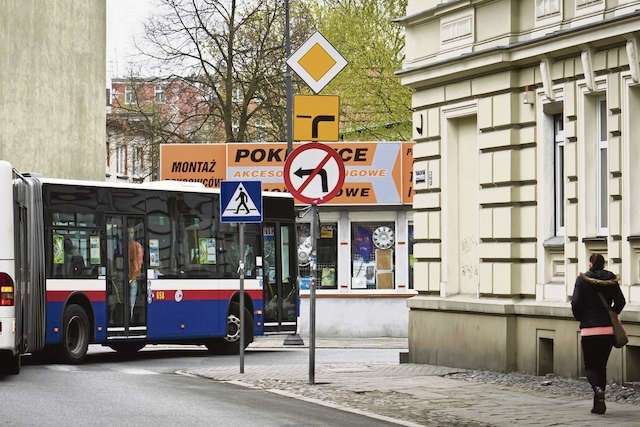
<box><xmin>287</xmin><ymin>31</ymin><xmax>347</xmax><ymax>93</ymax></box>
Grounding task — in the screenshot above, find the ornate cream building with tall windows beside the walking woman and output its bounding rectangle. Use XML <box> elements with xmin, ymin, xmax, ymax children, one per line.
<box><xmin>398</xmin><ymin>0</ymin><xmax>640</xmax><ymax>381</ymax></box>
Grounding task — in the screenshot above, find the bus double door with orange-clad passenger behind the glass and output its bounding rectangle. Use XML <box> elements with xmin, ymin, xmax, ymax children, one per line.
<box><xmin>106</xmin><ymin>215</ymin><xmax>147</xmax><ymax>340</ymax></box>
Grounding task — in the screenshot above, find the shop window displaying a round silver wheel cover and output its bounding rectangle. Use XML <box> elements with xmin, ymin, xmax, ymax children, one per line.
<box><xmin>351</xmin><ymin>222</ymin><xmax>395</xmax><ymax>289</ymax></box>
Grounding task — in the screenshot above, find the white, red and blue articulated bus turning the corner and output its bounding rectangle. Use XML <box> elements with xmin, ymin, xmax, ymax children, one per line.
<box><xmin>0</xmin><ymin>161</ymin><xmax>298</xmax><ymax>373</ymax></box>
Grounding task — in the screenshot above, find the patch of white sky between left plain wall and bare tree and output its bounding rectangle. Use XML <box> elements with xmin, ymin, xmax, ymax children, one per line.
<box><xmin>107</xmin><ymin>0</ymin><xmax>157</xmax><ymax>84</ymax></box>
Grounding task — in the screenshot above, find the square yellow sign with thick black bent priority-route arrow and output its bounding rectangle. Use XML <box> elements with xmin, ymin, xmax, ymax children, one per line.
<box><xmin>293</xmin><ymin>95</ymin><xmax>340</xmax><ymax>141</ymax></box>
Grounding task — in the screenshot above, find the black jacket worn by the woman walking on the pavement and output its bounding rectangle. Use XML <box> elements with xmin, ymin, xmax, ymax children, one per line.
<box><xmin>571</xmin><ymin>270</ymin><xmax>626</xmax><ymax>329</ymax></box>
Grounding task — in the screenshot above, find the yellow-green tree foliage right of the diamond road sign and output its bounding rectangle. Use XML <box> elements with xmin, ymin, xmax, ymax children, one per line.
<box><xmin>313</xmin><ymin>0</ymin><xmax>411</xmax><ymax>140</ymax></box>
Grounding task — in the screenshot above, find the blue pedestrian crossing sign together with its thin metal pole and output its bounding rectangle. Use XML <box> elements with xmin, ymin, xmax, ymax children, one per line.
<box><xmin>220</xmin><ymin>181</ymin><xmax>262</xmax><ymax>374</ymax></box>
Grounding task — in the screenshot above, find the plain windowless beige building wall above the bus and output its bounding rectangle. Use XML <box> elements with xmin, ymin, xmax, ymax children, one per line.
<box><xmin>0</xmin><ymin>0</ymin><xmax>106</xmax><ymax>180</ymax></box>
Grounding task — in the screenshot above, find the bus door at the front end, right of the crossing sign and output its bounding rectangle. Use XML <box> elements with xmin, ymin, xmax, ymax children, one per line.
<box><xmin>262</xmin><ymin>222</ymin><xmax>298</xmax><ymax>333</ymax></box>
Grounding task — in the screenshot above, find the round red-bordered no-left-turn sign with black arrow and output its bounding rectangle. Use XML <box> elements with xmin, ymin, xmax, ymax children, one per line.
<box><xmin>284</xmin><ymin>142</ymin><xmax>345</xmax><ymax>204</ymax></box>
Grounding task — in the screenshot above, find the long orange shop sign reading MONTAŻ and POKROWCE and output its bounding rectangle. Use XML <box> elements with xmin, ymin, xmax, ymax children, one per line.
<box><xmin>160</xmin><ymin>142</ymin><xmax>413</xmax><ymax>205</ymax></box>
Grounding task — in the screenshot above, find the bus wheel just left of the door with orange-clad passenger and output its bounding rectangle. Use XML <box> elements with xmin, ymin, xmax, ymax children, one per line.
<box><xmin>60</xmin><ymin>304</ymin><xmax>89</xmax><ymax>364</ymax></box>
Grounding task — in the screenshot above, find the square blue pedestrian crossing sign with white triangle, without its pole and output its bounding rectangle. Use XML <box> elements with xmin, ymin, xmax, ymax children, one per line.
<box><xmin>220</xmin><ymin>181</ymin><xmax>262</xmax><ymax>222</ymax></box>
